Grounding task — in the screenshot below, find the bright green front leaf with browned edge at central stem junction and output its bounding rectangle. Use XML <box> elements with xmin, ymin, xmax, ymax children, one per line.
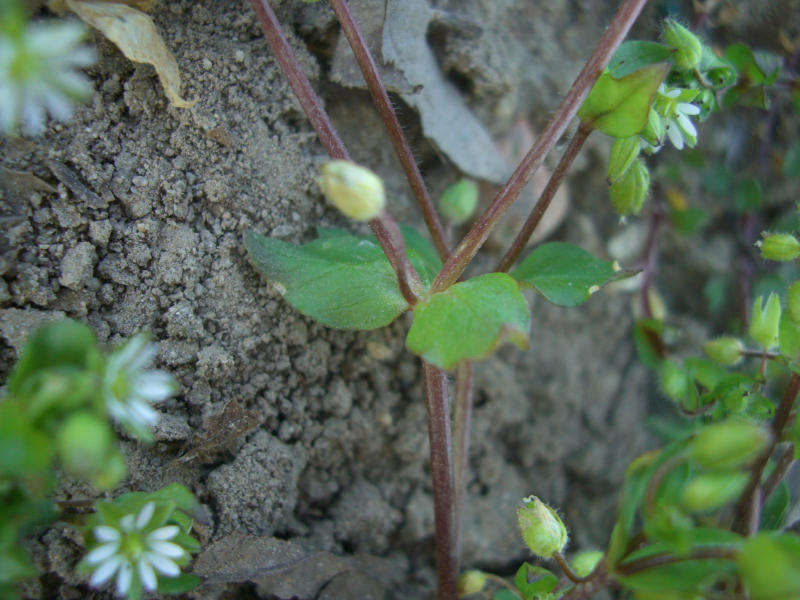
<box><xmin>406</xmin><ymin>273</ymin><xmax>530</xmax><ymax>369</ymax></box>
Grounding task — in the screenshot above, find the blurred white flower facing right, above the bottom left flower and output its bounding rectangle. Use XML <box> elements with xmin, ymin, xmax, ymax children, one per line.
<box><xmin>103</xmin><ymin>333</ymin><xmax>178</xmax><ymax>438</ymax></box>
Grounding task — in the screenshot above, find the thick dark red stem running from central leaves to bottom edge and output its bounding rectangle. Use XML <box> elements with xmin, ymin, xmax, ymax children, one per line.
<box><xmin>422</xmin><ymin>360</ymin><xmax>459</xmax><ymax>600</ymax></box>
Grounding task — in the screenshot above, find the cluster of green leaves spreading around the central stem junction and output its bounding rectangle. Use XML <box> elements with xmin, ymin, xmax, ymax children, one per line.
<box><xmin>246</xmin><ymin>228</ymin><xmax>617</xmax><ymax>369</ymax></box>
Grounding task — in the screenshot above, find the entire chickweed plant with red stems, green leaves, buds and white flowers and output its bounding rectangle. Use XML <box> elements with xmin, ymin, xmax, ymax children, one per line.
<box><xmin>0</xmin><ymin>0</ymin><xmax>800</xmax><ymax>600</ymax></box>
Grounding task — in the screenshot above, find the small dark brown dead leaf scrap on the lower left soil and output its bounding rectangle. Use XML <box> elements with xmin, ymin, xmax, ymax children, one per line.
<box><xmin>178</xmin><ymin>400</ymin><xmax>262</xmax><ymax>464</ymax></box>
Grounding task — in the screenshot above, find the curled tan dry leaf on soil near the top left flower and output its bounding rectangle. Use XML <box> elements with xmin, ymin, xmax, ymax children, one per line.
<box><xmin>66</xmin><ymin>0</ymin><xmax>196</xmax><ymax>108</ymax></box>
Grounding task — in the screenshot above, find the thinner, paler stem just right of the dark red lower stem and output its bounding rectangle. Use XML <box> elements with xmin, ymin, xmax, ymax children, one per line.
<box><xmin>453</xmin><ymin>360</ymin><xmax>473</xmax><ymax>557</ymax></box>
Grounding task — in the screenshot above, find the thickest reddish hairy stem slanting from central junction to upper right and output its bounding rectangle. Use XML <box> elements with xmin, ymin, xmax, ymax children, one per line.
<box><xmin>431</xmin><ymin>0</ymin><xmax>647</xmax><ymax>292</ymax></box>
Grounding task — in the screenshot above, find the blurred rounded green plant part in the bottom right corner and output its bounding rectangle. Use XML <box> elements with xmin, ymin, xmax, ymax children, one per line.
<box><xmin>737</xmin><ymin>532</ymin><xmax>800</xmax><ymax>600</ymax></box>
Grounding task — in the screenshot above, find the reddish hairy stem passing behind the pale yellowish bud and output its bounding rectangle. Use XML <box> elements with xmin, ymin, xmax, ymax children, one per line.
<box><xmin>250</xmin><ymin>0</ymin><xmax>421</xmax><ymax>305</ymax></box>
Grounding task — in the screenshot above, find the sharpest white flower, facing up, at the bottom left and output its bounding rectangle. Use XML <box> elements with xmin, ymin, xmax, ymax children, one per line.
<box><xmin>86</xmin><ymin>502</ymin><xmax>188</xmax><ymax>596</ymax></box>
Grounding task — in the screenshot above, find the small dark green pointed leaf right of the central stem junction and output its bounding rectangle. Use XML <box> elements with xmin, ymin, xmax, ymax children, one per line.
<box><xmin>511</xmin><ymin>242</ymin><xmax>620</xmax><ymax>306</ymax></box>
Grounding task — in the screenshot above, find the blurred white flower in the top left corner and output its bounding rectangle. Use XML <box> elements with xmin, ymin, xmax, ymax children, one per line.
<box><xmin>0</xmin><ymin>16</ymin><xmax>95</xmax><ymax>135</ymax></box>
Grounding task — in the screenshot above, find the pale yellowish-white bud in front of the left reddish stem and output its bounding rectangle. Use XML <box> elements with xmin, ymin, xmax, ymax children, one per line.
<box><xmin>317</xmin><ymin>160</ymin><xmax>386</xmax><ymax>221</ymax></box>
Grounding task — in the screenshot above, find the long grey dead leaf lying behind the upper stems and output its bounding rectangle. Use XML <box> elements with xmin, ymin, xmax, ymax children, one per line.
<box><xmin>382</xmin><ymin>0</ymin><xmax>511</xmax><ymax>183</ymax></box>
